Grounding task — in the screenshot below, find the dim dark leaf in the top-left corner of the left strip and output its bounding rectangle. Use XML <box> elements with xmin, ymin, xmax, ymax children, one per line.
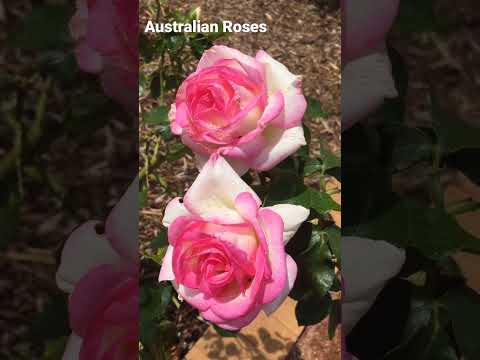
<box><xmin>13</xmin><ymin>5</ymin><xmax>71</xmax><ymax>50</ymax></box>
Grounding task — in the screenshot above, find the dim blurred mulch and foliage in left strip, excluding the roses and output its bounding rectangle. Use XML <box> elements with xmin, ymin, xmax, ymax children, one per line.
<box><xmin>0</xmin><ymin>0</ymin><xmax>138</xmax><ymax>360</ymax></box>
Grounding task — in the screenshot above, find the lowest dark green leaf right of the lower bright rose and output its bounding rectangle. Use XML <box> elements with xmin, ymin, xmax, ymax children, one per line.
<box><xmin>295</xmin><ymin>292</ymin><xmax>332</xmax><ymax>326</ymax></box>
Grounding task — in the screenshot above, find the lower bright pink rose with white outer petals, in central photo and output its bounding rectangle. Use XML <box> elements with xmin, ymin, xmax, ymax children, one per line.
<box><xmin>159</xmin><ymin>155</ymin><xmax>309</xmax><ymax>330</ymax></box>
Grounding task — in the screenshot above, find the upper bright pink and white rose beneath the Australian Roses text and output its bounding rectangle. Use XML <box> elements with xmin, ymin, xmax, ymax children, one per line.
<box><xmin>169</xmin><ymin>46</ymin><xmax>307</xmax><ymax>174</ymax></box>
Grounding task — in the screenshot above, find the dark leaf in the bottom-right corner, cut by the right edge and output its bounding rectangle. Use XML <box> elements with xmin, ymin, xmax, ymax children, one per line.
<box><xmin>441</xmin><ymin>287</ymin><xmax>480</xmax><ymax>359</ymax></box>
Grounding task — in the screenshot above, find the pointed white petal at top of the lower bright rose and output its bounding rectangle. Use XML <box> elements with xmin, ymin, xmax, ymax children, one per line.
<box><xmin>184</xmin><ymin>155</ymin><xmax>261</xmax><ymax>224</ymax></box>
